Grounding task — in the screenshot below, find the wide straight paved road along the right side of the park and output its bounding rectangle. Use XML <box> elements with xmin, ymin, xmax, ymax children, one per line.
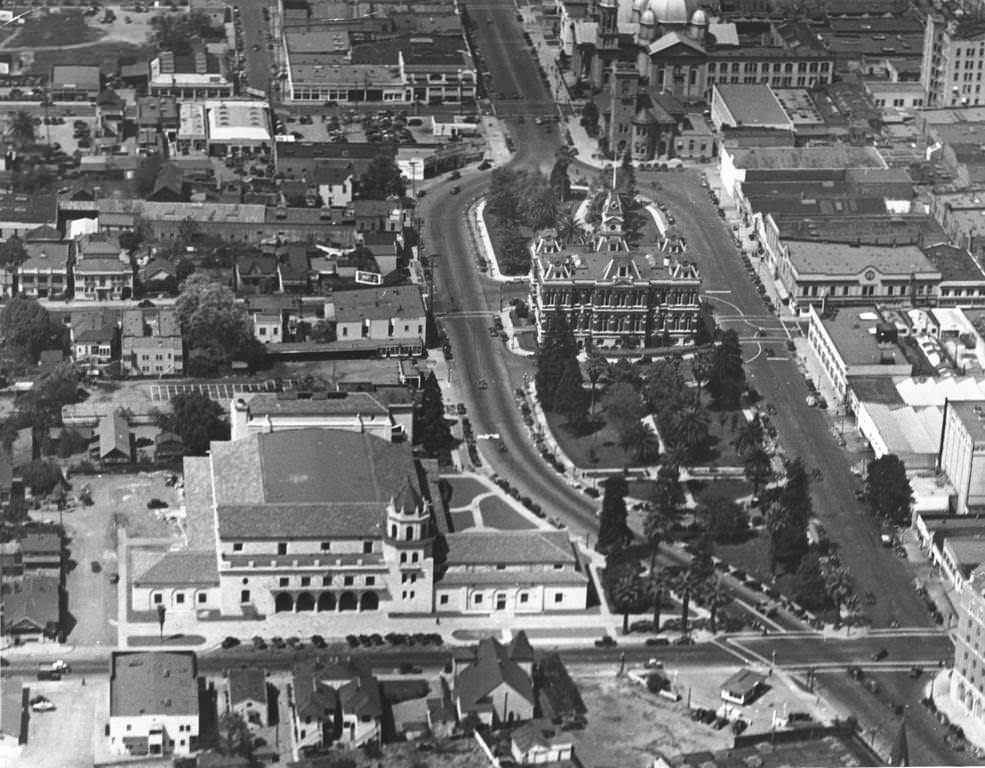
<box><xmin>637</xmin><ymin>172</ymin><xmax>930</xmax><ymax>627</ymax></box>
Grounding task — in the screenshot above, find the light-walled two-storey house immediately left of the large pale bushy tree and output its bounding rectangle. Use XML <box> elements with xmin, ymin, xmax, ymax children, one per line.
<box><xmin>120</xmin><ymin>307</ymin><xmax>185</xmax><ymax>377</ymax></box>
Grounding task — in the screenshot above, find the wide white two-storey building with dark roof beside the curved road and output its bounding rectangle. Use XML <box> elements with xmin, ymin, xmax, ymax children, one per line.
<box><xmin>325</xmin><ymin>285</ymin><xmax>427</xmax><ymax>355</ymax></box>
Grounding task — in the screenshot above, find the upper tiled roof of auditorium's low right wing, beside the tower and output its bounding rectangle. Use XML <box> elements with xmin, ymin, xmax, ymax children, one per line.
<box><xmin>446</xmin><ymin>531</ymin><xmax>577</xmax><ymax>575</ymax></box>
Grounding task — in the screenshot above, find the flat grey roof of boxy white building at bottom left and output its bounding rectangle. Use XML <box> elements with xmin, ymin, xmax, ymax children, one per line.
<box><xmin>109</xmin><ymin>651</ymin><xmax>199</xmax><ymax>717</ymax></box>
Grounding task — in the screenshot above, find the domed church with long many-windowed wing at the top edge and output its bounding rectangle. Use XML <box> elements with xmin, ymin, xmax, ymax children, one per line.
<box><xmin>557</xmin><ymin>0</ymin><xmax>834</xmax><ymax>103</ymax></box>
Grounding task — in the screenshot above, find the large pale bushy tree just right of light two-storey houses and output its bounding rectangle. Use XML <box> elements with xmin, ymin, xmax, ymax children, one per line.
<box><xmin>175</xmin><ymin>274</ymin><xmax>264</xmax><ymax>376</ymax></box>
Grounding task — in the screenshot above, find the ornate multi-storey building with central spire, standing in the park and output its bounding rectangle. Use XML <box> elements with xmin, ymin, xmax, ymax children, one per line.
<box><xmin>530</xmin><ymin>184</ymin><xmax>701</xmax><ymax>348</ymax></box>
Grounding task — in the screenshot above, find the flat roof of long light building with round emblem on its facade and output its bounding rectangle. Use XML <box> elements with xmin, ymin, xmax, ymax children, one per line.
<box><xmin>786</xmin><ymin>240</ymin><xmax>940</xmax><ymax>278</ymax></box>
